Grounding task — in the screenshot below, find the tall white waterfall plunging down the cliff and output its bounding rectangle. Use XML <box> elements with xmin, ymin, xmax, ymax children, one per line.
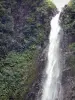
<box><xmin>41</xmin><ymin>12</ymin><xmax>61</xmax><ymax>100</ymax></box>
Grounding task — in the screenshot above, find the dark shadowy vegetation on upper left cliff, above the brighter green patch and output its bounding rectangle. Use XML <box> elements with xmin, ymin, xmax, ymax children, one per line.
<box><xmin>0</xmin><ymin>0</ymin><xmax>56</xmax><ymax>58</ymax></box>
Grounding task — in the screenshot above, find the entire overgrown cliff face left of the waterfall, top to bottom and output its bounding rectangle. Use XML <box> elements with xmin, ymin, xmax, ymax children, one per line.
<box><xmin>0</xmin><ymin>0</ymin><xmax>57</xmax><ymax>100</ymax></box>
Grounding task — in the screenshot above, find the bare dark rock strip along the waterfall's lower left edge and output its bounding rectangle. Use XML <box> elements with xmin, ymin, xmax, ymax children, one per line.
<box><xmin>25</xmin><ymin>47</ymin><xmax>48</xmax><ymax>100</ymax></box>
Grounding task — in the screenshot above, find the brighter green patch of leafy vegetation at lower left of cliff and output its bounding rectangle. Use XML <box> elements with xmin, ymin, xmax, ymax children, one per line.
<box><xmin>0</xmin><ymin>50</ymin><xmax>38</xmax><ymax>100</ymax></box>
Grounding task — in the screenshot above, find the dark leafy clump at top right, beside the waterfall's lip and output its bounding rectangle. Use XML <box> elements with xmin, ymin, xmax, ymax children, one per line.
<box><xmin>61</xmin><ymin>0</ymin><xmax>75</xmax><ymax>36</ymax></box>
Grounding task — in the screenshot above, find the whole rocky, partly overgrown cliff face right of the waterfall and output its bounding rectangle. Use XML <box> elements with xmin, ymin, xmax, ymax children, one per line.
<box><xmin>60</xmin><ymin>0</ymin><xmax>75</xmax><ymax>100</ymax></box>
